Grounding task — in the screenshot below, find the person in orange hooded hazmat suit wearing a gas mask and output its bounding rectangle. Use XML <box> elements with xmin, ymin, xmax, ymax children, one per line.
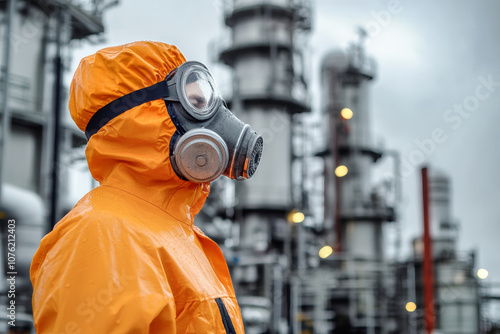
<box><xmin>31</xmin><ymin>42</ymin><xmax>262</xmax><ymax>334</ymax></box>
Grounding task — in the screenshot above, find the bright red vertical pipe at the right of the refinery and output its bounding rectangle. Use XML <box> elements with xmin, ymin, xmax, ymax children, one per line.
<box><xmin>422</xmin><ymin>167</ymin><xmax>435</xmax><ymax>334</ymax></box>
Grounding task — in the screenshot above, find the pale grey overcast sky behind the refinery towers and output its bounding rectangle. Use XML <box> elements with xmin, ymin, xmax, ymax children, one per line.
<box><xmin>71</xmin><ymin>0</ymin><xmax>500</xmax><ymax>288</ymax></box>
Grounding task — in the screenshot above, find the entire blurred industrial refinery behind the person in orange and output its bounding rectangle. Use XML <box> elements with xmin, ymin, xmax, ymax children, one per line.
<box><xmin>0</xmin><ymin>0</ymin><xmax>500</xmax><ymax>334</ymax></box>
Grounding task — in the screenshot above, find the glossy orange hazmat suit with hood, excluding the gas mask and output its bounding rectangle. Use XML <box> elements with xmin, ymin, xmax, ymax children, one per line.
<box><xmin>31</xmin><ymin>42</ymin><xmax>244</xmax><ymax>334</ymax></box>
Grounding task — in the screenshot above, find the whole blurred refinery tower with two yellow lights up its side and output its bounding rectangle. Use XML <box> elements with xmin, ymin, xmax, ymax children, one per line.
<box><xmin>321</xmin><ymin>45</ymin><xmax>395</xmax><ymax>334</ymax></box>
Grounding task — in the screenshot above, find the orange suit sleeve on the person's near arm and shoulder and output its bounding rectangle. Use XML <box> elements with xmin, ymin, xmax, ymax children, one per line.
<box><xmin>32</xmin><ymin>220</ymin><xmax>176</xmax><ymax>334</ymax></box>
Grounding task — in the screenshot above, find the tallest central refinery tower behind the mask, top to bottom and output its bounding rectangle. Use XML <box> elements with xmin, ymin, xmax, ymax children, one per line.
<box><xmin>220</xmin><ymin>0</ymin><xmax>310</xmax><ymax>333</ymax></box>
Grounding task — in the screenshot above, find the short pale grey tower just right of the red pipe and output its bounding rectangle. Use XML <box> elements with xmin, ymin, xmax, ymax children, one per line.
<box><xmin>429</xmin><ymin>168</ymin><xmax>480</xmax><ymax>334</ymax></box>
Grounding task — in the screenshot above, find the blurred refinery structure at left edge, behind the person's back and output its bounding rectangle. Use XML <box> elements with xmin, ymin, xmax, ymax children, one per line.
<box><xmin>0</xmin><ymin>0</ymin><xmax>112</xmax><ymax>333</ymax></box>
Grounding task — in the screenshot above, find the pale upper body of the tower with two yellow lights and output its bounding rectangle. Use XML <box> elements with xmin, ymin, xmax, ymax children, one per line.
<box><xmin>321</xmin><ymin>46</ymin><xmax>386</xmax><ymax>260</ymax></box>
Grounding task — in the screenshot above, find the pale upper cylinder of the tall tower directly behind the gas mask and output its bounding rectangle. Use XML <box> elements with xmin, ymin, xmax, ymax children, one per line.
<box><xmin>220</xmin><ymin>0</ymin><xmax>308</xmax><ymax>210</ymax></box>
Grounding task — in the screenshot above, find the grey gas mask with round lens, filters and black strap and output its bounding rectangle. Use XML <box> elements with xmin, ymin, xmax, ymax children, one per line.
<box><xmin>85</xmin><ymin>61</ymin><xmax>263</xmax><ymax>183</ymax></box>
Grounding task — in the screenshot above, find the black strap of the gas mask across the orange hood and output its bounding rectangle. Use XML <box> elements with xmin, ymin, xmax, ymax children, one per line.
<box><xmin>85</xmin><ymin>80</ymin><xmax>169</xmax><ymax>140</ymax></box>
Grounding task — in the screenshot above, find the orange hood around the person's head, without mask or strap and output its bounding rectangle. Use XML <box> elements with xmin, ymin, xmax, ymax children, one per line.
<box><xmin>69</xmin><ymin>42</ymin><xmax>210</xmax><ymax>224</ymax></box>
